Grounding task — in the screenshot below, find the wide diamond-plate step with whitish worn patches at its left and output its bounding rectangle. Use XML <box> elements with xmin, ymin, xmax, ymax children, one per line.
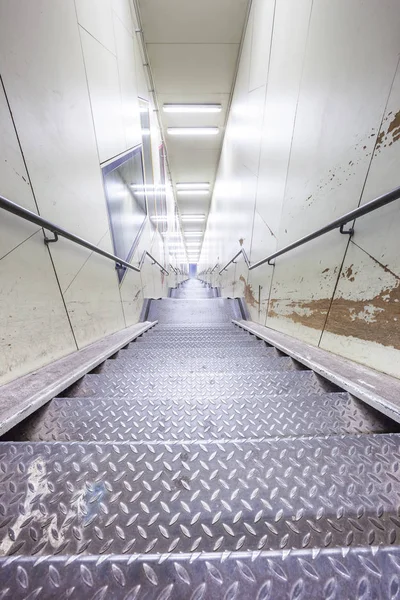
<box><xmin>0</xmin><ymin>434</ymin><xmax>400</xmax><ymax>556</ymax></box>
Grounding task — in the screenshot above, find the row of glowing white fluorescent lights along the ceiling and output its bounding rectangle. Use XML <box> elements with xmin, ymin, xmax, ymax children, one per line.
<box><xmin>163</xmin><ymin>104</ymin><xmax>222</xmax><ymax>259</ymax></box>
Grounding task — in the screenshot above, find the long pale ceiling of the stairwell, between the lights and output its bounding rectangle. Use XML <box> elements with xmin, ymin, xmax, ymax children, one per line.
<box><xmin>138</xmin><ymin>0</ymin><xmax>248</xmax><ymax>246</ymax></box>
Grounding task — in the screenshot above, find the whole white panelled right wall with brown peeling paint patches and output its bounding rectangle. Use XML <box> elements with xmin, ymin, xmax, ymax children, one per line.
<box><xmin>199</xmin><ymin>0</ymin><xmax>400</xmax><ymax>377</ymax></box>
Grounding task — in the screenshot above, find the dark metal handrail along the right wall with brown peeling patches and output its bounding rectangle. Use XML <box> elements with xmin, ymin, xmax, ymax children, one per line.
<box><xmin>219</xmin><ymin>187</ymin><xmax>400</xmax><ymax>275</ymax></box>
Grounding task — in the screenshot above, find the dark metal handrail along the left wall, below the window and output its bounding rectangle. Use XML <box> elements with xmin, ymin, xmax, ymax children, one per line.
<box><xmin>0</xmin><ymin>196</ymin><xmax>169</xmax><ymax>275</ymax></box>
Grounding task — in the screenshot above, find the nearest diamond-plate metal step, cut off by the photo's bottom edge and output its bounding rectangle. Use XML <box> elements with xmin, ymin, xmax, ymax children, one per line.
<box><xmin>0</xmin><ymin>546</ymin><xmax>400</xmax><ymax>600</ymax></box>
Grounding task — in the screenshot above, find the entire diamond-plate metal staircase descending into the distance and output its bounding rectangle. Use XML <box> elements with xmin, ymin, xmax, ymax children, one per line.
<box><xmin>0</xmin><ymin>280</ymin><xmax>400</xmax><ymax>600</ymax></box>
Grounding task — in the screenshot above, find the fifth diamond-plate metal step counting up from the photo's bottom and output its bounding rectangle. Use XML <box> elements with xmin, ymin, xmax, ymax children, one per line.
<box><xmin>101</xmin><ymin>353</ymin><xmax>297</xmax><ymax>374</ymax></box>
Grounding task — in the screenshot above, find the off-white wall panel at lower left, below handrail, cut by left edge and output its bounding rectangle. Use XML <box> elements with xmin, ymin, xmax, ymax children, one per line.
<box><xmin>0</xmin><ymin>231</ymin><xmax>76</xmax><ymax>384</ymax></box>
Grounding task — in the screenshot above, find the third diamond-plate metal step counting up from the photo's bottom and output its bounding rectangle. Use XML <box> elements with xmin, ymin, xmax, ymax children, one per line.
<box><xmin>12</xmin><ymin>393</ymin><xmax>399</xmax><ymax>442</ymax></box>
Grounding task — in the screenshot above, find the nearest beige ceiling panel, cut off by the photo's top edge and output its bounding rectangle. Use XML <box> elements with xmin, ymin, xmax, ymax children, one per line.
<box><xmin>140</xmin><ymin>0</ymin><xmax>248</xmax><ymax>44</ymax></box>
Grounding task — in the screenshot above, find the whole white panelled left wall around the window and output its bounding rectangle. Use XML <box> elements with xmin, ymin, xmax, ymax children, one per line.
<box><xmin>0</xmin><ymin>0</ymin><xmax>181</xmax><ymax>383</ymax></box>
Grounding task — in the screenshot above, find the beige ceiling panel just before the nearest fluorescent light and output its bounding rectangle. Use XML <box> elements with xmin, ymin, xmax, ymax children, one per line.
<box><xmin>147</xmin><ymin>44</ymin><xmax>239</xmax><ymax>95</ymax></box>
